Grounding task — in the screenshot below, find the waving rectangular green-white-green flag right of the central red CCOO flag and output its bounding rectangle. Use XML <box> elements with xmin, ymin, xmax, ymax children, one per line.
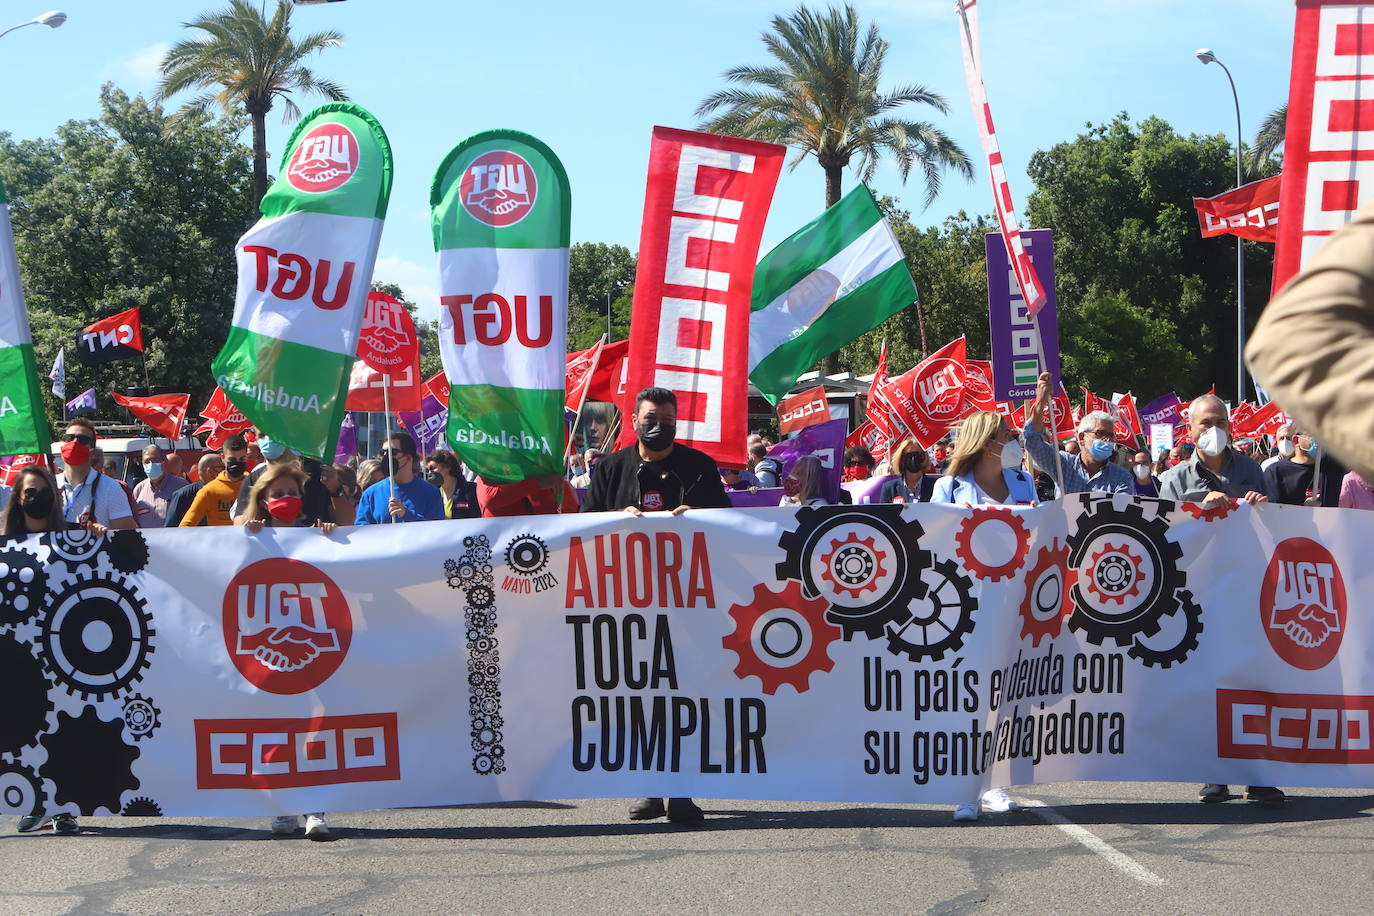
<box><xmin>749</xmin><ymin>184</ymin><xmax>916</xmax><ymax>404</ymax></box>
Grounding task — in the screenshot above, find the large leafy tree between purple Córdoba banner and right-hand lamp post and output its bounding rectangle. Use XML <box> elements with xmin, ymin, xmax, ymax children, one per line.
<box><xmin>1028</xmin><ymin>114</ymin><xmax>1274</xmax><ymax>397</ymax></box>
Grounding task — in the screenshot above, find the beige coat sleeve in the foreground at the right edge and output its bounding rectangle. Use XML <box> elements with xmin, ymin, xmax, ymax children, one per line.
<box><xmin>1245</xmin><ymin>207</ymin><xmax>1374</xmax><ymax>479</ymax></box>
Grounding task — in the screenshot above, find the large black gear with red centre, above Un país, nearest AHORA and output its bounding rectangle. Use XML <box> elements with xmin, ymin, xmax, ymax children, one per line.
<box><xmin>776</xmin><ymin>505</ymin><xmax>932</xmax><ymax>640</ymax></box>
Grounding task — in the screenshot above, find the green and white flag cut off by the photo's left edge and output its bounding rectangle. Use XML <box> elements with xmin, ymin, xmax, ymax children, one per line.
<box><xmin>0</xmin><ymin>174</ymin><xmax>52</xmax><ymax>455</ymax></box>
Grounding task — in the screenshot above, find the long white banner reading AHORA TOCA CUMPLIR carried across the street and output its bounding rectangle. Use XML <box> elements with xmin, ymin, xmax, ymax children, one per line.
<box><xmin>0</xmin><ymin>496</ymin><xmax>1374</xmax><ymax>816</ymax></box>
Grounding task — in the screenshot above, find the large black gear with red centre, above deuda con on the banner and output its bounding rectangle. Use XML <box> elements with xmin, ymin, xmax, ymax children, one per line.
<box><xmin>1069</xmin><ymin>500</ymin><xmax>1186</xmax><ymax>645</ymax></box>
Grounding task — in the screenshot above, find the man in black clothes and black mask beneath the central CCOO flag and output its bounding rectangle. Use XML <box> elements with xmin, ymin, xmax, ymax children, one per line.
<box><xmin>581</xmin><ymin>387</ymin><xmax>730</xmax><ymax>824</ymax></box>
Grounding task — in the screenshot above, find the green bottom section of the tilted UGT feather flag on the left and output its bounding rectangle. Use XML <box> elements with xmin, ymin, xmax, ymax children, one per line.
<box><xmin>210</xmin><ymin>327</ymin><xmax>353</xmax><ymax>459</ymax></box>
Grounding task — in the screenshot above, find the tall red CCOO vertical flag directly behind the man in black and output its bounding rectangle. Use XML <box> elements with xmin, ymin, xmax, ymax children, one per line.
<box><xmin>620</xmin><ymin>128</ymin><xmax>786</xmax><ymax>466</ymax></box>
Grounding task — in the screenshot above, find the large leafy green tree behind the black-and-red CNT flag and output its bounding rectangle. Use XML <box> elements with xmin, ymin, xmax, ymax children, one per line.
<box><xmin>0</xmin><ymin>85</ymin><xmax>253</xmax><ymax>417</ymax></box>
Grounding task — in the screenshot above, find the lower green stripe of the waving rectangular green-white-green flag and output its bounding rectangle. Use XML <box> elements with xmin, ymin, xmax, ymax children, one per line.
<box><xmin>749</xmin><ymin>261</ymin><xmax>915</xmax><ymax>404</ymax></box>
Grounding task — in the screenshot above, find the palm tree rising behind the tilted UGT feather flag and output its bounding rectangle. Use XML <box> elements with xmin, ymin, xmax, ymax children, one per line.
<box><xmin>157</xmin><ymin>0</ymin><xmax>348</xmax><ymax>207</ymax></box>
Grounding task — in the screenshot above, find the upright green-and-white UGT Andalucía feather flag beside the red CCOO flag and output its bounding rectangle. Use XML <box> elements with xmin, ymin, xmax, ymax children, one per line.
<box><xmin>430</xmin><ymin>130</ymin><xmax>572</xmax><ymax>483</ymax></box>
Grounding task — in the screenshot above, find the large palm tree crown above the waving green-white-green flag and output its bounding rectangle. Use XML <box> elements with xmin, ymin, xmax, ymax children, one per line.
<box><xmin>695</xmin><ymin>5</ymin><xmax>973</xmax><ymax>207</ymax></box>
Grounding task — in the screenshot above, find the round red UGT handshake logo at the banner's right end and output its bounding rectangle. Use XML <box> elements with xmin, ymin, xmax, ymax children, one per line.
<box><xmin>1260</xmin><ymin>537</ymin><xmax>1345</xmax><ymax>672</ymax></box>
